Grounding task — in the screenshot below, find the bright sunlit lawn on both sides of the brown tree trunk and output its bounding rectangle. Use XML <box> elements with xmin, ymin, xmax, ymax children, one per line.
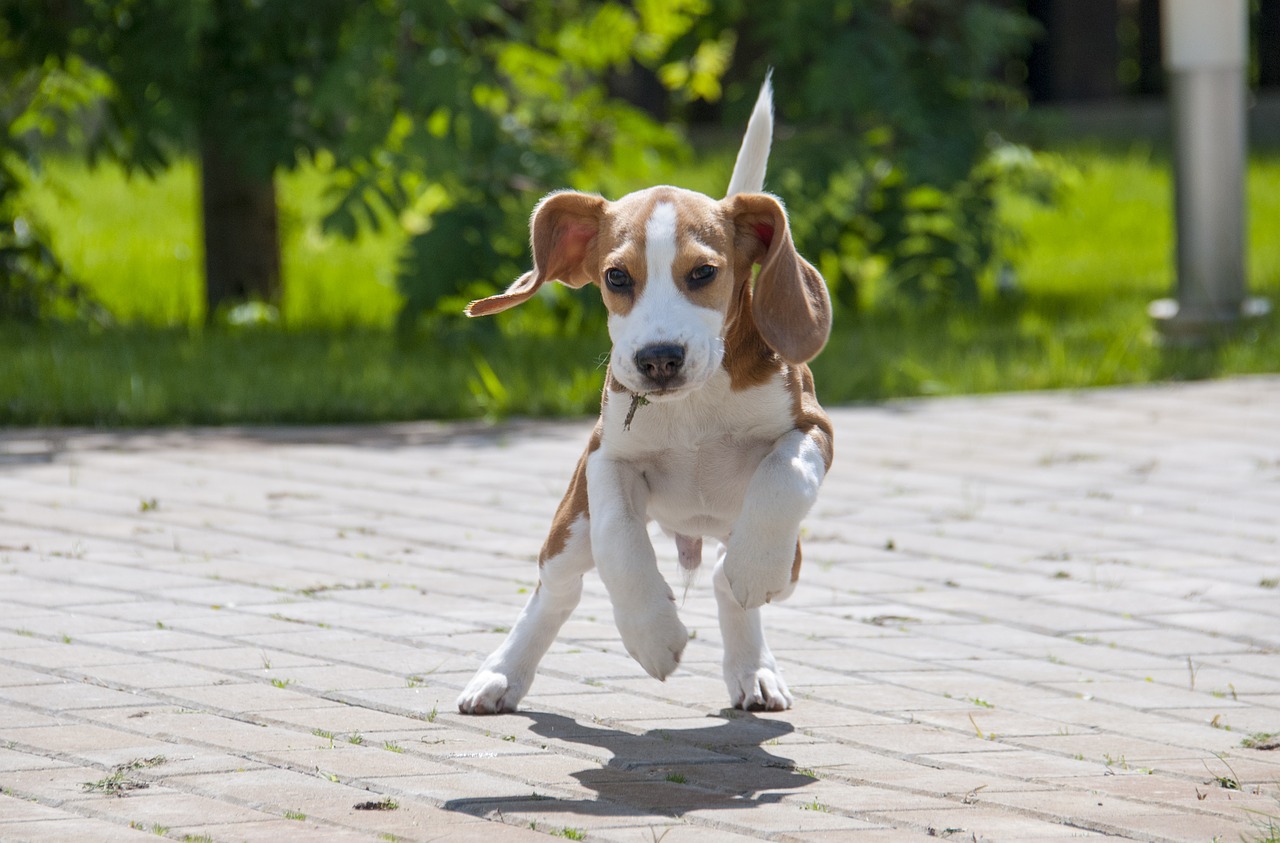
<box><xmin>32</xmin><ymin>160</ymin><xmax>402</xmax><ymax>329</ymax></box>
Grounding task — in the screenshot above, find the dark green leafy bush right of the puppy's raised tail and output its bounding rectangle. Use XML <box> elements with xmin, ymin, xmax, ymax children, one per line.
<box><xmin>742</xmin><ymin>0</ymin><xmax>1047</xmax><ymax>310</ymax></box>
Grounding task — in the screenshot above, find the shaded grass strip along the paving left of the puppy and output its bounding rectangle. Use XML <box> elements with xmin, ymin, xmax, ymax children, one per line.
<box><xmin>0</xmin><ymin>325</ymin><xmax>604</xmax><ymax>426</ymax></box>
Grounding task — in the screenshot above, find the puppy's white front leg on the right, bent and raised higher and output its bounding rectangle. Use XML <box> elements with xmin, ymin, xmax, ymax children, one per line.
<box><xmin>724</xmin><ymin>430</ymin><xmax>827</xmax><ymax>609</ymax></box>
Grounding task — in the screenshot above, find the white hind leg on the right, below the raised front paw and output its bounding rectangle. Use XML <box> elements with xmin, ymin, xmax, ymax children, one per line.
<box><xmin>712</xmin><ymin>553</ymin><xmax>792</xmax><ymax>711</ymax></box>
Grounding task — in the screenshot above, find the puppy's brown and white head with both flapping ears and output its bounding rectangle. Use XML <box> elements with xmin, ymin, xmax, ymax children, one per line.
<box><xmin>467</xmin><ymin>187</ymin><xmax>831</xmax><ymax>400</ymax></box>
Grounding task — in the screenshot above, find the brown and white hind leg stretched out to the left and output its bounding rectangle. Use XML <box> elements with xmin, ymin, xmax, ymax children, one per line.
<box><xmin>458</xmin><ymin>447</ymin><xmax>593</xmax><ymax>714</ymax></box>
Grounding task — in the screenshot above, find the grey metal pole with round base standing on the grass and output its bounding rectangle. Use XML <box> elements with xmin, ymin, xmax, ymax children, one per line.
<box><xmin>1151</xmin><ymin>0</ymin><xmax>1270</xmax><ymax>342</ymax></box>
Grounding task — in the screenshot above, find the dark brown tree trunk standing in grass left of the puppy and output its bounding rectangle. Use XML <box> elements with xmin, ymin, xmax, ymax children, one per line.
<box><xmin>200</xmin><ymin>133</ymin><xmax>280</xmax><ymax>321</ymax></box>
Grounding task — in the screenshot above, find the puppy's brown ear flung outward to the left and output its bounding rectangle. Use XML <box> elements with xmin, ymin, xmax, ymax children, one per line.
<box><xmin>466</xmin><ymin>191</ymin><xmax>605</xmax><ymax>316</ymax></box>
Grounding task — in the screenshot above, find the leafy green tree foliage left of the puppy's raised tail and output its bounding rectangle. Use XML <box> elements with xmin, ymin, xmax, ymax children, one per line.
<box><xmin>0</xmin><ymin>0</ymin><xmax>731</xmax><ymax>326</ymax></box>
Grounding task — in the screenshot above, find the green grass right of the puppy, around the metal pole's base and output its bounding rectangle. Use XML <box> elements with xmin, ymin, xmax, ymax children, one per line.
<box><xmin>814</xmin><ymin>146</ymin><xmax>1280</xmax><ymax>400</ymax></box>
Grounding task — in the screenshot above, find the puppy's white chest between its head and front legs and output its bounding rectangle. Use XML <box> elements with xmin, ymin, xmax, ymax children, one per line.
<box><xmin>603</xmin><ymin>375</ymin><xmax>795</xmax><ymax>537</ymax></box>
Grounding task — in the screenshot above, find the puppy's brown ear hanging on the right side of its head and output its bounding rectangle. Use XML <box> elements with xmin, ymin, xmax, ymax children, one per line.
<box><xmin>724</xmin><ymin>193</ymin><xmax>831</xmax><ymax>363</ymax></box>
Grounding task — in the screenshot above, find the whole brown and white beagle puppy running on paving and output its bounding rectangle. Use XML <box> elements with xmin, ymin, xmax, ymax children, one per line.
<box><xmin>458</xmin><ymin>79</ymin><xmax>832</xmax><ymax>714</ymax></box>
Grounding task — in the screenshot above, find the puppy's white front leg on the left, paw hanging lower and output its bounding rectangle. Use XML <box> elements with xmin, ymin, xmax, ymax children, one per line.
<box><xmin>586</xmin><ymin>452</ymin><xmax>689</xmax><ymax>679</ymax></box>
